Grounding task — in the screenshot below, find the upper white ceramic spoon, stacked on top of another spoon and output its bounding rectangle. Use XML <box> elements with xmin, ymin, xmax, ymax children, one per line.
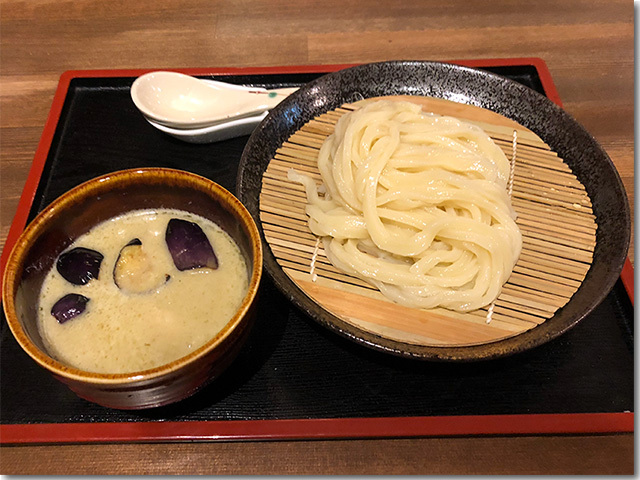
<box><xmin>131</xmin><ymin>71</ymin><xmax>297</xmax><ymax>129</ymax></box>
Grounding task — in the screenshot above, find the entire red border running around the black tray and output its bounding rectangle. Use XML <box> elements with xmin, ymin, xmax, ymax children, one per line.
<box><xmin>0</xmin><ymin>57</ymin><xmax>634</xmax><ymax>444</ymax></box>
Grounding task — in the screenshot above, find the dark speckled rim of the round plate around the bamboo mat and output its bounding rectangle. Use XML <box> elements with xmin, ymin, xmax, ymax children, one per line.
<box><xmin>236</xmin><ymin>61</ymin><xmax>631</xmax><ymax>361</ymax></box>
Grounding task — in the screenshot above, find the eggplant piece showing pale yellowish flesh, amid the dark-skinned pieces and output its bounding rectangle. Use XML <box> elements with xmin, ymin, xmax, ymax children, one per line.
<box><xmin>113</xmin><ymin>238</ymin><xmax>171</xmax><ymax>293</ymax></box>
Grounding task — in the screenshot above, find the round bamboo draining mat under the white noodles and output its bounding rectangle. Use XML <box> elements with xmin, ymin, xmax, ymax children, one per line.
<box><xmin>260</xmin><ymin>96</ymin><xmax>597</xmax><ymax>346</ymax></box>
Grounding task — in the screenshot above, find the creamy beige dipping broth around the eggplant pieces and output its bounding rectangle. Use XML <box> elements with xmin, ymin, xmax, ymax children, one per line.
<box><xmin>38</xmin><ymin>209</ymin><xmax>249</xmax><ymax>373</ymax></box>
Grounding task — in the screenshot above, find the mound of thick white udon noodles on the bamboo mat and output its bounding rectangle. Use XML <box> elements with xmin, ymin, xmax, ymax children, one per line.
<box><xmin>288</xmin><ymin>100</ymin><xmax>522</xmax><ymax>311</ymax></box>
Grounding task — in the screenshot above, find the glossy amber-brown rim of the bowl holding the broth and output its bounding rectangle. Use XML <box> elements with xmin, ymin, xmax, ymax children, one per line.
<box><xmin>2</xmin><ymin>167</ymin><xmax>263</xmax><ymax>385</ymax></box>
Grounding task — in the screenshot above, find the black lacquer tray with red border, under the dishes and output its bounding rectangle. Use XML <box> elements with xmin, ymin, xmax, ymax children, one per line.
<box><xmin>0</xmin><ymin>59</ymin><xmax>634</xmax><ymax>443</ymax></box>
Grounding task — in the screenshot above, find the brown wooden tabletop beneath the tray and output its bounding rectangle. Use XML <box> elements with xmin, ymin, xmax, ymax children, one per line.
<box><xmin>0</xmin><ymin>0</ymin><xmax>634</xmax><ymax>474</ymax></box>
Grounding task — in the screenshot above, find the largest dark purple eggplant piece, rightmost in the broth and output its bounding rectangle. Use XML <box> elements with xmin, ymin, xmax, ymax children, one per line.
<box><xmin>165</xmin><ymin>218</ymin><xmax>218</xmax><ymax>271</ymax></box>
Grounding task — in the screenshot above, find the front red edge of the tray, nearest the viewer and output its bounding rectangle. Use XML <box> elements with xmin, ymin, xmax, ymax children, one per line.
<box><xmin>0</xmin><ymin>412</ymin><xmax>634</xmax><ymax>445</ymax></box>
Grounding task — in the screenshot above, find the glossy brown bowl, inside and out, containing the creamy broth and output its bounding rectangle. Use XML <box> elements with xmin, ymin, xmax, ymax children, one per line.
<box><xmin>2</xmin><ymin>168</ymin><xmax>262</xmax><ymax>409</ymax></box>
